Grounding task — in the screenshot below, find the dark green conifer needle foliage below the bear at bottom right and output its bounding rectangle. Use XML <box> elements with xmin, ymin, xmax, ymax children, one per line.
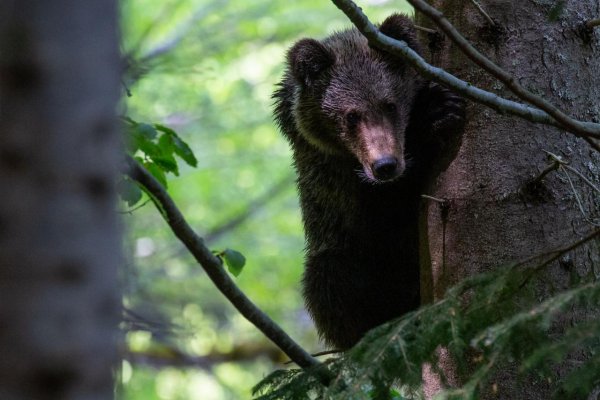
<box><xmin>254</xmin><ymin>232</ymin><xmax>600</xmax><ymax>400</ymax></box>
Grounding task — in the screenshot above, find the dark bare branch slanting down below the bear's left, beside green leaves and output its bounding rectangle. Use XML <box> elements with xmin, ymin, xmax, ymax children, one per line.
<box><xmin>125</xmin><ymin>156</ymin><xmax>321</xmax><ymax>369</ymax></box>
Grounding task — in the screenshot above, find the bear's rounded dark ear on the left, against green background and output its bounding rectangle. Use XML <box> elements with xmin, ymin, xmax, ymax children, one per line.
<box><xmin>288</xmin><ymin>39</ymin><xmax>335</xmax><ymax>86</ymax></box>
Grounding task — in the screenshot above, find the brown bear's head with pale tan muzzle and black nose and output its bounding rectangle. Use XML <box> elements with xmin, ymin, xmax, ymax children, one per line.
<box><xmin>288</xmin><ymin>14</ymin><xmax>424</xmax><ymax>183</ymax></box>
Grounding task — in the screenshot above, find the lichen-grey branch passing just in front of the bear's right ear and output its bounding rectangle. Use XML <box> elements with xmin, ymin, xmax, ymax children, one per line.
<box><xmin>332</xmin><ymin>0</ymin><xmax>600</xmax><ymax>142</ymax></box>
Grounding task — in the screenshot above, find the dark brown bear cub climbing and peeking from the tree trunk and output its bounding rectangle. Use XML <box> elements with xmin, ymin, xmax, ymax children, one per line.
<box><xmin>273</xmin><ymin>14</ymin><xmax>465</xmax><ymax>349</ymax></box>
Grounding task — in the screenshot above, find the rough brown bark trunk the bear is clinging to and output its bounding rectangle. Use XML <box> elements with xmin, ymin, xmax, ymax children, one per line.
<box><xmin>417</xmin><ymin>0</ymin><xmax>600</xmax><ymax>399</ymax></box>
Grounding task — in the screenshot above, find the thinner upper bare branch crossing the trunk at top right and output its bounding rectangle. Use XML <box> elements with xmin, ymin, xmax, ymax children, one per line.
<box><xmin>408</xmin><ymin>0</ymin><xmax>600</xmax><ymax>138</ymax></box>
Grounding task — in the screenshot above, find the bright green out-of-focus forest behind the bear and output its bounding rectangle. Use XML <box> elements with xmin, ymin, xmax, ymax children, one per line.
<box><xmin>119</xmin><ymin>0</ymin><xmax>412</xmax><ymax>400</ymax></box>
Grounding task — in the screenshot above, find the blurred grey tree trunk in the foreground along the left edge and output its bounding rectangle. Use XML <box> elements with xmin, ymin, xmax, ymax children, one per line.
<box><xmin>0</xmin><ymin>0</ymin><xmax>120</xmax><ymax>400</ymax></box>
